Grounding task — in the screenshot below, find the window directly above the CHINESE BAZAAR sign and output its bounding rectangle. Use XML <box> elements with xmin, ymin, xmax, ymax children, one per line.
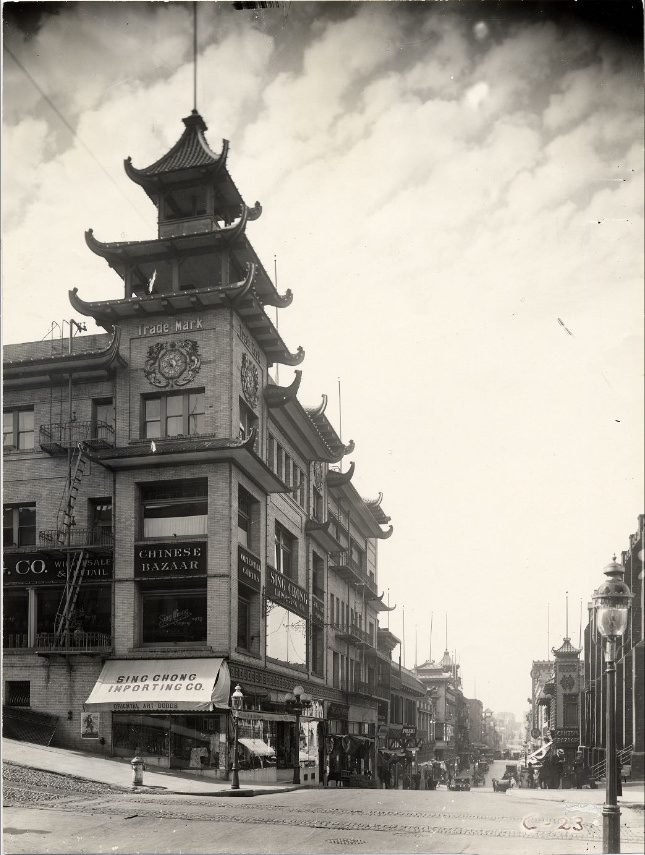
<box><xmin>141</xmin><ymin>478</ymin><xmax>208</xmax><ymax>539</ymax></box>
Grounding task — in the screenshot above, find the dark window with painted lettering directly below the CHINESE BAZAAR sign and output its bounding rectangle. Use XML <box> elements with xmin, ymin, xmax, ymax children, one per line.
<box><xmin>141</xmin><ymin>579</ymin><xmax>206</xmax><ymax>644</ymax></box>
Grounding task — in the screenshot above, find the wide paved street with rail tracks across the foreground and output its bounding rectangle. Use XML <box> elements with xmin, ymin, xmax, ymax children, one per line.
<box><xmin>3</xmin><ymin>765</ymin><xmax>643</xmax><ymax>855</ymax></box>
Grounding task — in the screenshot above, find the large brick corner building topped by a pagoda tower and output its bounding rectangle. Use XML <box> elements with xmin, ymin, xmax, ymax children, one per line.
<box><xmin>3</xmin><ymin>111</ymin><xmax>392</xmax><ymax>784</ymax></box>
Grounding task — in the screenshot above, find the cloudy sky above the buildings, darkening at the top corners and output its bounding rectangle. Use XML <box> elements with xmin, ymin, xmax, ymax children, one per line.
<box><xmin>3</xmin><ymin>0</ymin><xmax>644</xmax><ymax>715</ymax></box>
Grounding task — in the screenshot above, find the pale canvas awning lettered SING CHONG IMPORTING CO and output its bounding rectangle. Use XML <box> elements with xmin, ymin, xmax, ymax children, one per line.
<box><xmin>84</xmin><ymin>658</ymin><xmax>231</xmax><ymax>713</ymax></box>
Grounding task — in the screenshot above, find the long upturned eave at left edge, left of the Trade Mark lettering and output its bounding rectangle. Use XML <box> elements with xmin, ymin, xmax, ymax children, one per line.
<box><xmin>3</xmin><ymin>328</ymin><xmax>127</xmax><ymax>387</ymax></box>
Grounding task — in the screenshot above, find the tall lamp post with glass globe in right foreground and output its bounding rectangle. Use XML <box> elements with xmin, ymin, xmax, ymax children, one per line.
<box><xmin>592</xmin><ymin>555</ymin><xmax>632</xmax><ymax>853</ymax></box>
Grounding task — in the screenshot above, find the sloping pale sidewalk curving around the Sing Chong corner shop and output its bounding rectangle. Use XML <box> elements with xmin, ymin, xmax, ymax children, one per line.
<box><xmin>2</xmin><ymin>738</ymin><xmax>300</xmax><ymax>797</ymax></box>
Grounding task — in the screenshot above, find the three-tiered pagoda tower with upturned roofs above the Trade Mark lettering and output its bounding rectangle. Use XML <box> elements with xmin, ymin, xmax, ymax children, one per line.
<box><xmin>70</xmin><ymin>110</ymin><xmax>304</xmax><ymax>366</ymax></box>
